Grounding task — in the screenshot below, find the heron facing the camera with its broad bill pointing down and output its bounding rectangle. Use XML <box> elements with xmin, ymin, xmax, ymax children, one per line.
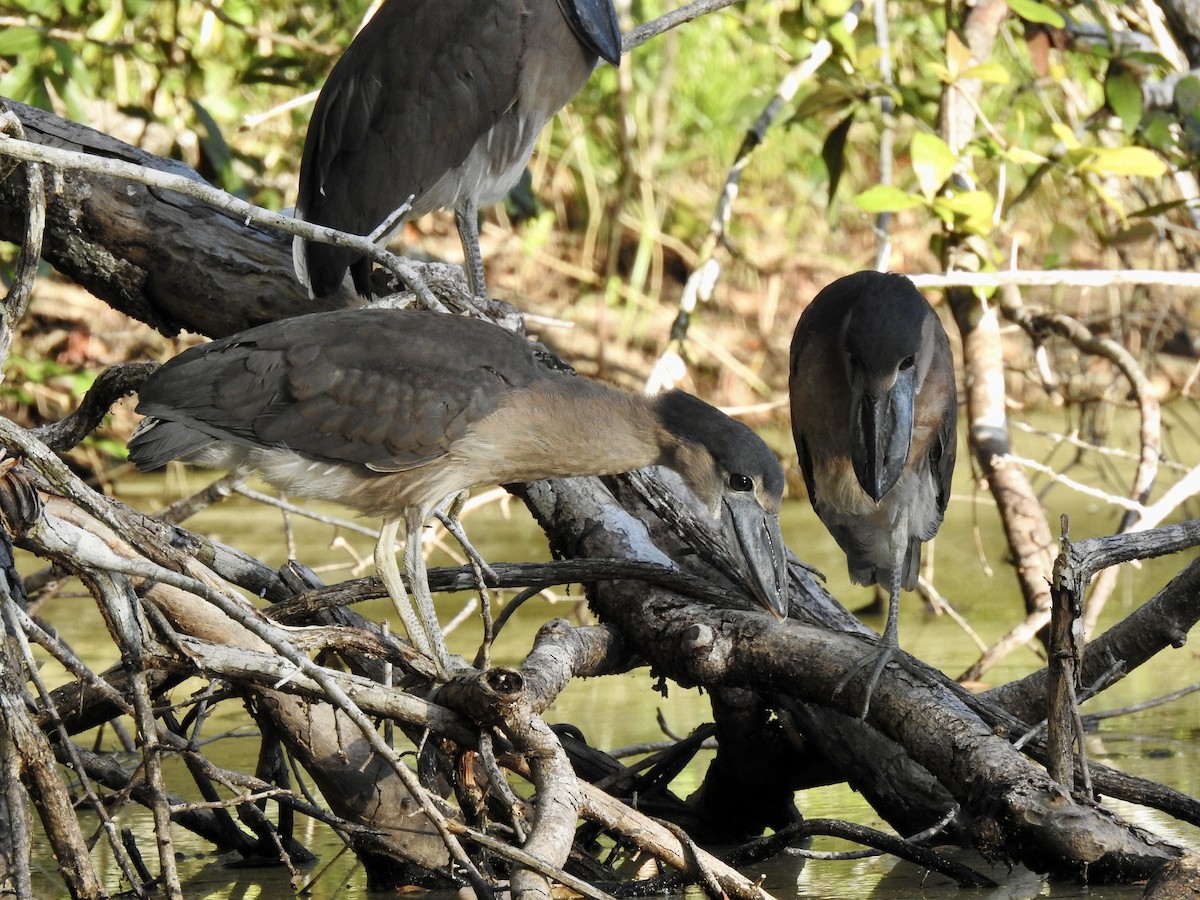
<box><xmin>790</xmin><ymin>271</ymin><xmax>958</xmax><ymax>716</ymax></box>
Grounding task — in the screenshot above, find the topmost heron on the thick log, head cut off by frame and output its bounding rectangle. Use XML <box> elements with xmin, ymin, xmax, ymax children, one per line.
<box><xmin>293</xmin><ymin>0</ymin><xmax>620</xmax><ymax>296</ymax></box>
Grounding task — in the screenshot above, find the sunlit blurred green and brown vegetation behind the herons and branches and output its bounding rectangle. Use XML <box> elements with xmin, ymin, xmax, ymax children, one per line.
<box><xmin>0</xmin><ymin>0</ymin><xmax>1200</xmax><ymax>439</ymax></box>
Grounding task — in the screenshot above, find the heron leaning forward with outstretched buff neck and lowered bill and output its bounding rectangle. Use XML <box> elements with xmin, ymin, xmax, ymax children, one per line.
<box><xmin>130</xmin><ymin>308</ymin><xmax>787</xmax><ymax>677</ymax></box>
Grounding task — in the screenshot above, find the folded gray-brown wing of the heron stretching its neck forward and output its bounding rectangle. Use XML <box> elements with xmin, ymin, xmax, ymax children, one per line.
<box><xmin>138</xmin><ymin>310</ymin><xmax>545</xmax><ymax>470</ymax></box>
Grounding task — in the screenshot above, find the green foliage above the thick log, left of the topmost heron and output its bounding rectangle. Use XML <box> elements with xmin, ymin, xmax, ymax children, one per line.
<box><xmin>0</xmin><ymin>0</ymin><xmax>367</xmax><ymax>204</ymax></box>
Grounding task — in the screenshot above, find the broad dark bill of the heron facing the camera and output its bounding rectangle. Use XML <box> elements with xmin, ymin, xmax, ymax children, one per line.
<box><xmin>850</xmin><ymin>370</ymin><xmax>917</xmax><ymax>503</ymax></box>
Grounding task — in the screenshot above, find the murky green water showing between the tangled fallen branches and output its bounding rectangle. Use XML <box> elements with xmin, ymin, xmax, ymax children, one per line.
<box><xmin>23</xmin><ymin>417</ymin><xmax>1200</xmax><ymax>900</ymax></box>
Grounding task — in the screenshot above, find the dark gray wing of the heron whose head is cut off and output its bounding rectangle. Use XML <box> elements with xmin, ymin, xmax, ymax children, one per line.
<box><xmin>296</xmin><ymin>0</ymin><xmax>522</xmax><ymax>243</ymax></box>
